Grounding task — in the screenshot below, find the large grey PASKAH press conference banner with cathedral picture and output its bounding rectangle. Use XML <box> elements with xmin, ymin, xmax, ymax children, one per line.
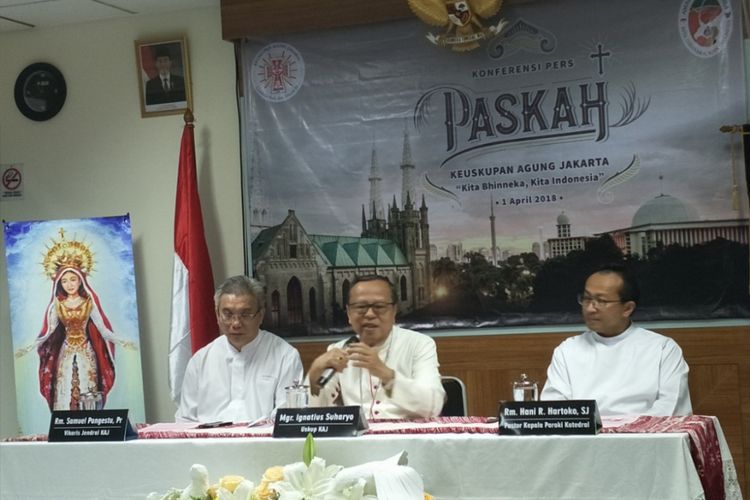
<box><xmin>243</xmin><ymin>0</ymin><xmax>750</xmax><ymax>335</ymax></box>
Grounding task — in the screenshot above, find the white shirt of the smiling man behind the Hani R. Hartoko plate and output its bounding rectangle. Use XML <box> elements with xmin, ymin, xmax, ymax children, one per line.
<box><xmin>541</xmin><ymin>325</ymin><xmax>693</xmax><ymax>416</ymax></box>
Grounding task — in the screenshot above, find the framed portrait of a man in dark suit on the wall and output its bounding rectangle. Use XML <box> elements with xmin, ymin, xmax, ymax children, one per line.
<box><xmin>135</xmin><ymin>37</ymin><xmax>193</xmax><ymax>118</ymax></box>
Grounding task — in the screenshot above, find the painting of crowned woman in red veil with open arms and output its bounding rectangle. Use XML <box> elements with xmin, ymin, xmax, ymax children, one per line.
<box><xmin>3</xmin><ymin>215</ymin><xmax>145</xmax><ymax>435</ymax></box>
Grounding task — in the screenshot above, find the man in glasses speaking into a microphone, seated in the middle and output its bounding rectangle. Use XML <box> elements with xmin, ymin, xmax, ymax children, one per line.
<box><xmin>307</xmin><ymin>275</ymin><xmax>445</xmax><ymax>418</ymax></box>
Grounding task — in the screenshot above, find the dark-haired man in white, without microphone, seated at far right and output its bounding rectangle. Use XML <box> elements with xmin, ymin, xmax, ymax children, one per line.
<box><xmin>541</xmin><ymin>264</ymin><xmax>692</xmax><ymax>416</ymax></box>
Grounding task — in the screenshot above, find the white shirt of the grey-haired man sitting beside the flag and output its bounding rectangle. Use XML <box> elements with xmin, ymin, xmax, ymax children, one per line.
<box><xmin>175</xmin><ymin>330</ymin><xmax>303</xmax><ymax>422</ymax></box>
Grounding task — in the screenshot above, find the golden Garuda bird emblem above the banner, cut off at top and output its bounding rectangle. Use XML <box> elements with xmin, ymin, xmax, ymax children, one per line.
<box><xmin>408</xmin><ymin>0</ymin><xmax>507</xmax><ymax>52</ymax></box>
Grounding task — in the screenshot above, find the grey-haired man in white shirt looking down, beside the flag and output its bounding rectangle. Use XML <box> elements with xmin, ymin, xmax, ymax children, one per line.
<box><xmin>175</xmin><ymin>276</ymin><xmax>302</xmax><ymax>423</ymax></box>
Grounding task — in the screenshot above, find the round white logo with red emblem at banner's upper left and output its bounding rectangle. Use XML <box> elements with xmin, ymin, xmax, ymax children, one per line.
<box><xmin>250</xmin><ymin>43</ymin><xmax>305</xmax><ymax>102</ymax></box>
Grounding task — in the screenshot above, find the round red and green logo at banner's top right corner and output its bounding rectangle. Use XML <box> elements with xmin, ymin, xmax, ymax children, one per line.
<box><xmin>679</xmin><ymin>0</ymin><xmax>733</xmax><ymax>57</ymax></box>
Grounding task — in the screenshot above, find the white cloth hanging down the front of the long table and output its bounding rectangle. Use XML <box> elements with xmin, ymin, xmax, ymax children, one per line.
<box><xmin>0</xmin><ymin>420</ymin><xmax>739</xmax><ymax>500</ymax></box>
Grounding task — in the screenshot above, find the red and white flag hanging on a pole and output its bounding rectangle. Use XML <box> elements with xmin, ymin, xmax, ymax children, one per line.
<box><xmin>169</xmin><ymin>110</ymin><xmax>218</xmax><ymax>402</ymax></box>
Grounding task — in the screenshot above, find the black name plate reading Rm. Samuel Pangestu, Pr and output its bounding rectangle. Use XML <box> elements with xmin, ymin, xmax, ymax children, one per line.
<box><xmin>47</xmin><ymin>410</ymin><xmax>138</xmax><ymax>442</ymax></box>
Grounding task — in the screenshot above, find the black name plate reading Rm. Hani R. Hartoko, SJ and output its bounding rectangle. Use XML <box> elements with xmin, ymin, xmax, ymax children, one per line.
<box><xmin>499</xmin><ymin>399</ymin><xmax>602</xmax><ymax>436</ymax></box>
